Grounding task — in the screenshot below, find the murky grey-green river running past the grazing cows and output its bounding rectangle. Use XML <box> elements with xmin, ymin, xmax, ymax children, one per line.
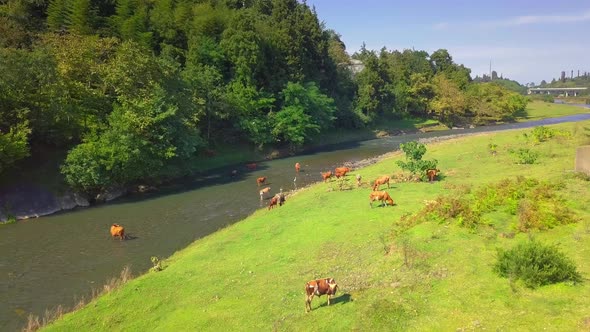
<box><xmin>0</xmin><ymin>114</ymin><xmax>590</xmax><ymax>331</ymax></box>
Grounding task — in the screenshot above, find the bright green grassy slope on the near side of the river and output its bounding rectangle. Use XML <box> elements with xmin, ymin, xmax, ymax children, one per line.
<box><xmin>46</xmin><ymin>122</ymin><xmax>590</xmax><ymax>331</ymax></box>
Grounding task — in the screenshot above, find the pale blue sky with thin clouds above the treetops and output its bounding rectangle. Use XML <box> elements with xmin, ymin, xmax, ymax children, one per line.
<box><xmin>307</xmin><ymin>0</ymin><xmax>590</xmax><ymax>84</ymax></box>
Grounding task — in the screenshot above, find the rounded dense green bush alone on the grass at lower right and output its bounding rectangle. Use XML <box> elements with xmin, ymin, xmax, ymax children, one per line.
<box><xmin>494</xmin><ymin>241</ymin><xmax>582</xmax><ymax>288</ymax></box>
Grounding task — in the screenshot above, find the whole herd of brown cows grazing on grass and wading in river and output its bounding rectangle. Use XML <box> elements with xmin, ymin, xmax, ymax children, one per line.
<box><xmin>111</xmin><ymin>163</ymin><xmax>440</xmax><ymax>312</ymax></box>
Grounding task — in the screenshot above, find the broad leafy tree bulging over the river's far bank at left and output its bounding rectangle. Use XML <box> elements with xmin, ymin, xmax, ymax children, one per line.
<box><xmin>62</xmin><ymin>86</ymin><xmax>202</xmax><ymax>194</ymax></box>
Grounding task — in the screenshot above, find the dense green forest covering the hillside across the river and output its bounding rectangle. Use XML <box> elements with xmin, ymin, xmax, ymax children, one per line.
<box><xmin>0</xmin><ymin>0</ymin><xmax>526</xmax><ymax>194</ymax></box>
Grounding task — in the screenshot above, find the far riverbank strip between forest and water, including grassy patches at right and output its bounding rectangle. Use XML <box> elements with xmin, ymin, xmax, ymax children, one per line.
<box><xmin>0</xmin><ymin>101</ymin><xmax>589</xmax><ymax>224</ymax></box>
